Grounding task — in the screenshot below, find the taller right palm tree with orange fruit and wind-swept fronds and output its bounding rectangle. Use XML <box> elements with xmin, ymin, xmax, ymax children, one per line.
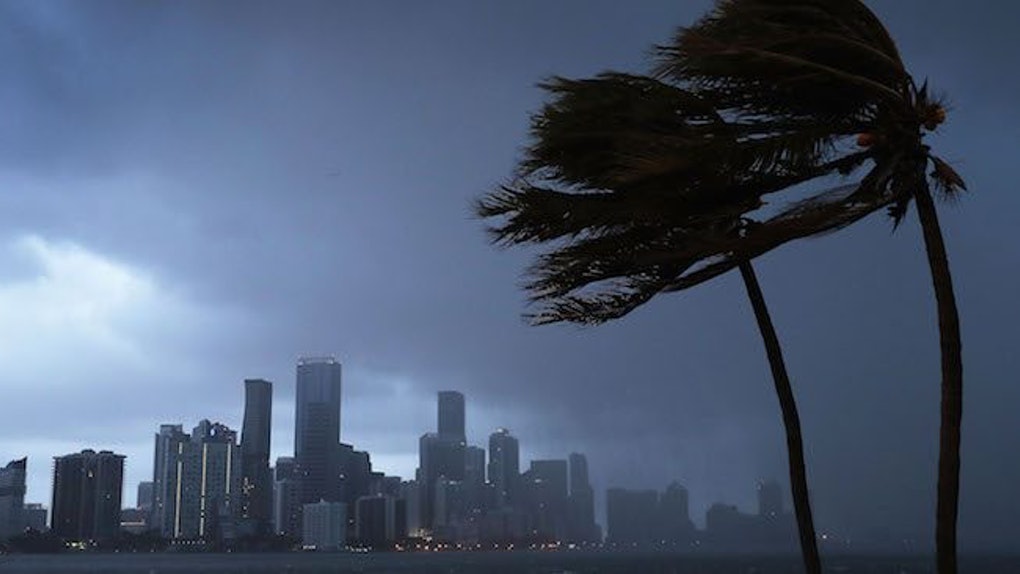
<box><xmin>657</xmin><ymin>0</ymin><xmax>966</xmax><ymax>574</ymax></box>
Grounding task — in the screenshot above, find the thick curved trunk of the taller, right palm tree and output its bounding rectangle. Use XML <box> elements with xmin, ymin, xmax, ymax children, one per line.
<box><xmin>914</xmin><ymin>183</ymin><xmax>963</xmax><ymax>574</ymax></box>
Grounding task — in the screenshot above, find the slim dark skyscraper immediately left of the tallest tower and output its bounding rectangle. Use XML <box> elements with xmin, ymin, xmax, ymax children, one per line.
<box><xmin>241</xmin><ymin>379</ymin><xmax>272</xmax><ymax>534</ymax></box>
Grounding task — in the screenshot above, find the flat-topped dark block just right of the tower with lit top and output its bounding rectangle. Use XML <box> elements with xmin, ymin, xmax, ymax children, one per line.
<box><xmin>523</xmin><ymin>460</ymin><xmax>567</xmax><ymax>540</ymax></box>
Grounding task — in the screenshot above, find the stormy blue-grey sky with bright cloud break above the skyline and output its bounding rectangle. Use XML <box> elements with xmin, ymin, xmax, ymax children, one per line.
<box><xmin>0</xmin><ymin>0</ymin><xmax>1020</xmax><ymax>547</ymax></box>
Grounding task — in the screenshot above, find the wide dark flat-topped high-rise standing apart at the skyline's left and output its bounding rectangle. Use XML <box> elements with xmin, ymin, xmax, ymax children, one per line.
<box><xmin>51</xmin><ymin>450</ymin><xmax>124</xmax><ymax>540</ymax></box>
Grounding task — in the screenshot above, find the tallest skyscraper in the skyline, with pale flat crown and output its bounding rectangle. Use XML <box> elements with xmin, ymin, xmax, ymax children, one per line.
<box><xmin>294</xmin><ymin>357</ymin><xmax>341</xmax><ymax>504</ymax></box>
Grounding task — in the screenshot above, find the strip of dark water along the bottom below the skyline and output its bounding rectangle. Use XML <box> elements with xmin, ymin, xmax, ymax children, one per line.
<box><xmin>0</xmin><ymin>553</ymin><xmax>1020</xmax><ymax>574</ymax></box>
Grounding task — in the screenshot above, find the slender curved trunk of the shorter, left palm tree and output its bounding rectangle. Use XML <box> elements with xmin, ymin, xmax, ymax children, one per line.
<box><xmin>740</xmin><ymin>261</ymin><xmax>822</xmax><ymax>574</ymax></box>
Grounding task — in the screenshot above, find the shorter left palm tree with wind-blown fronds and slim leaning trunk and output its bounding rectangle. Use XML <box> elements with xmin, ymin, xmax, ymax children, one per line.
<box><xmin>476</xmin><ymin>73</ymin><xmax>884</xmax><ymax>574</ymax></box>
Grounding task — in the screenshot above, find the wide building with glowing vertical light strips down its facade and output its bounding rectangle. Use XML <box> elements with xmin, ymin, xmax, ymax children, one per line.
<box><xmin>157</xmin><ymin>420</ymin><xmax>241</xmax><ymax>540</ymax></box>
